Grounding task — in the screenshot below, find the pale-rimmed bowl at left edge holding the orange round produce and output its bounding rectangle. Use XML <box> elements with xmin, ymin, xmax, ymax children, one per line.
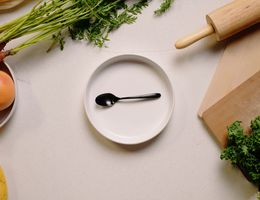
<box><xmin>0</xmin><ymin>62</ymin><xmax>17</xmax><ymax>128</ymax></box>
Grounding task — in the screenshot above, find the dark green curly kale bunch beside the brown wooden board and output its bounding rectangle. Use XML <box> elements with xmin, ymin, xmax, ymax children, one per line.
<box><xmin>220</xmin><ymin>116</ymin><xmax>260</xmax><ymax>198</ymax></box>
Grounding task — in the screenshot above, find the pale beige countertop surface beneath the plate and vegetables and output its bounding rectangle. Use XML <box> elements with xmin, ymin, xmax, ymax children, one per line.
<box><xmin>0</xmin><ymin>0</ymin><xmax>257</xmax><ymax>200</ymax></box>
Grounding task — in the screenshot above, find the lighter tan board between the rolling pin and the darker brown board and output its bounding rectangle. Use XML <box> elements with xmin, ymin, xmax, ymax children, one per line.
<box><xmin>198</xmin><ymin>25</ymin><xmax>260</xmax><ymax>117</ymax></box>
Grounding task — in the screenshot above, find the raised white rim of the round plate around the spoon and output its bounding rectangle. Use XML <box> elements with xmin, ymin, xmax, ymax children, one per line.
<box><xmin>84</xmin><ymin>54</ymin><xmax>175</xmax><ymax>145</ymax></box>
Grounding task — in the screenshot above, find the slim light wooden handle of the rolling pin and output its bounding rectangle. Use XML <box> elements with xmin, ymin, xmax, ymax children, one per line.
<box><xmin>175</xmin><ymin>24</ymin><xmax>215</xmax><ymax>49</ymax></box>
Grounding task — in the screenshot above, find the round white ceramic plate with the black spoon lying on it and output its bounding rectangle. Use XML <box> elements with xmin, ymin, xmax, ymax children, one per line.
<box><xmin>84</xmin><ymin>55</ymin><xmax>174</xmax><ymax>144</ymax></box>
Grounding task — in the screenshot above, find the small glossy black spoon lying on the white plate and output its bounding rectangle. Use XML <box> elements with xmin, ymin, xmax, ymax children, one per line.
<box><xmin>95</xmin><ymin>93</ymin><xmax>161</xmax><ymax>106</ymax></box>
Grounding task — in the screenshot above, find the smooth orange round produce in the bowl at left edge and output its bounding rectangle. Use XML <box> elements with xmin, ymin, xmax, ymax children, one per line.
<box><xmin>0</xmin><ymin>71</ymin><xmax>15</xmax><ymax>111</ymax></box>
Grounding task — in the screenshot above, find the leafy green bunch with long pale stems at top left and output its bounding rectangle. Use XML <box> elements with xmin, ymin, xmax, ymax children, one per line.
<box><xmin>0</xmin><ymin>0</ymin><xmax>173</xmax><ymax>62</ymax></box>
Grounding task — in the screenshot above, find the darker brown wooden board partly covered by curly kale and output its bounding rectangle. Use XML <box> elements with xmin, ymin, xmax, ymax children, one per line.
<box><xmin>202</xmin><ymin>71</ymin><xmax>260</xmax><ymax>146</ymax></box>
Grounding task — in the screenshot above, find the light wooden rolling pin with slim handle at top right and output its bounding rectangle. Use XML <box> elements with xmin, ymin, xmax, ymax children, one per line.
<box><xmin>175</xmin><ymin>0</ymin><xmax>260</xmax><ymax>49</ymax></box>
